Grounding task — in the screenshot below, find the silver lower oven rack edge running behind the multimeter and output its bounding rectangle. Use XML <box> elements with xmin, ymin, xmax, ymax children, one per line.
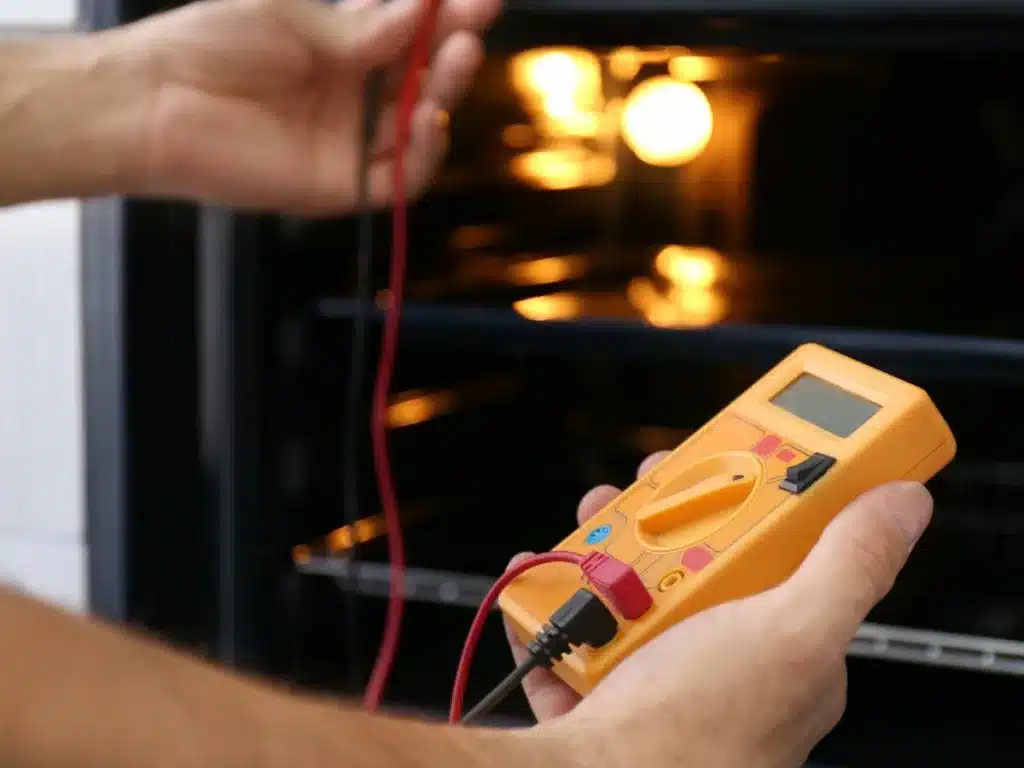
<box><xmin>296</xmin><ymin>557</ymin><xmax>1024</xmax><ymax>677</ymax></box>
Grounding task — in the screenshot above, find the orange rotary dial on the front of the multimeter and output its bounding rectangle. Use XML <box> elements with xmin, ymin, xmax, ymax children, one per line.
<box><xmin>636</xmin><ymin>451</ymin><xmax>764</xmax><ymax>552</ymax></box>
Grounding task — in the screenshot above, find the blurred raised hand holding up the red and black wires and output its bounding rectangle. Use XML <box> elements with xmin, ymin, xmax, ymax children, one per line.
<box><xmin>113</xmin><ymin>0</ymin><xmax>501</xmax><ymax>215</ymax></box>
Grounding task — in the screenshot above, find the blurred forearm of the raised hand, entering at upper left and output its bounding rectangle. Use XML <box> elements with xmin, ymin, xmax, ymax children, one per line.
<box><xmin>0</xmin><ymin>33</ymin><xmax>150</xmax><ymax>206</ymax></box>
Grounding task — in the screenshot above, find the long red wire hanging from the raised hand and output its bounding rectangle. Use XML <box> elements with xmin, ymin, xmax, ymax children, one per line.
<box><xmin>364</xmin><ymin>0</ymin><xmax>440</xmax><ymax>711</ymax></box>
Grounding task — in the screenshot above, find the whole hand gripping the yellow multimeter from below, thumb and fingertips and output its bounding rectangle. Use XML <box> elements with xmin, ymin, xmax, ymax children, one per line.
<box><xmin>511</xmin><ymin>455</ymin><xmax>932</xmax><ymax>768</ymax></box>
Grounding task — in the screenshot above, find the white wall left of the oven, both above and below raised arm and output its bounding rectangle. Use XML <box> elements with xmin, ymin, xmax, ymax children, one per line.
<box><xmin>0</xmin><ymin>0</ymin><xmax>88</xmax><ymax>609</ymax></box>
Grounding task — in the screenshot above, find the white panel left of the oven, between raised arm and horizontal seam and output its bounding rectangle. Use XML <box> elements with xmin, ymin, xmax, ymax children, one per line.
<box><xmin>0</xmin><ymin>202</ymin><xmax>84</xmax><ymax>544</ymax></box>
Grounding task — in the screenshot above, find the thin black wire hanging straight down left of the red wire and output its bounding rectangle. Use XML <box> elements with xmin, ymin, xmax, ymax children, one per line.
<box><xmin>342</xmin><ymin>71</ymin><xmax>385</xmax><ymax>687</ymax></box>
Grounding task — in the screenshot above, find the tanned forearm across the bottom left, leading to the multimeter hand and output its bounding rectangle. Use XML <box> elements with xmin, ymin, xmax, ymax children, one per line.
<box><xmin>0</xmin><ymin>590</ymin><xmax>566</xmax><ymax>768</ymax></box>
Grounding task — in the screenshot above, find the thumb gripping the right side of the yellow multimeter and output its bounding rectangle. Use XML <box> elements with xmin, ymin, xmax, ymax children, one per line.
<box><xmin>779</xmin><ymin>482</ymin><xmax>932</xmax><ymax>647</ymax></box>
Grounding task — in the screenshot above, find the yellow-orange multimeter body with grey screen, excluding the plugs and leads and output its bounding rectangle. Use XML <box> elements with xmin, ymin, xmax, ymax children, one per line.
<box><xmin>499</xmin><ymin>344</ymin><xmax>956</xmax><ymax>694</ymax></box>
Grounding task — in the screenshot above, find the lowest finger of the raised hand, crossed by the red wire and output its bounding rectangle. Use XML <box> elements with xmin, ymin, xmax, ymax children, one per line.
<box><xmin>370</xmin><ymin>101</ymin><xmax>447</xmax><ymax>207</ymax></box>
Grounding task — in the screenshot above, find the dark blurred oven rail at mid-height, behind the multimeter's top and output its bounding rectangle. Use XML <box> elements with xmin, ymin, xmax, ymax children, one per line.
<box><xmin>315</xmin><ymin>299</ymin><xmax>1024</xmax><ymax>383</ymax></box>
